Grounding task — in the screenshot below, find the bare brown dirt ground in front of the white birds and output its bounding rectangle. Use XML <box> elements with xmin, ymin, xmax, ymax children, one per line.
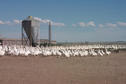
<box><xmin>0</xmin><ymin>52</ymin><xmax>126</xmax><ymax>84</ymax></box>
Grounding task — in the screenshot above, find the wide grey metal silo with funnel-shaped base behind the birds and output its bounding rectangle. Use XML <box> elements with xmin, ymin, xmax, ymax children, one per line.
<box><xmin>22</xmin><ymin>16</ymin><xmax>40</xmax><ymax>46</ymax></box>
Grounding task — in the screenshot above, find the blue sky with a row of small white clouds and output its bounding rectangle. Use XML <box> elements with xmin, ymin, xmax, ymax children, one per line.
<box><xmin>0</xmin><ymin>0</ymin><xmax>126</xmax><ymax>42</ymax></box>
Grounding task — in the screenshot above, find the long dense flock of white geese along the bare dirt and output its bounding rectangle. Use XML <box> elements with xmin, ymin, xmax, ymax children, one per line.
<box><xmin>0</xmin><ymin>45</ymin><xmax>126</xmax><ymax>57</ymax></box>
